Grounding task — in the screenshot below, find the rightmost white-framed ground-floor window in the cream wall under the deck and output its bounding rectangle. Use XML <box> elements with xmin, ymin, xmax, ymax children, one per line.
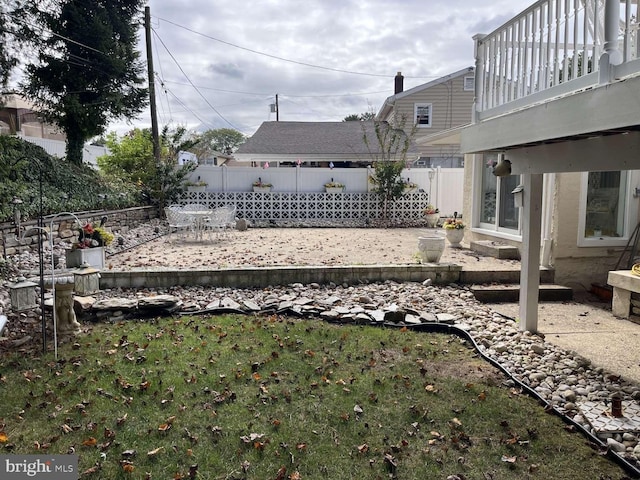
<box><xmin>578</xmin><ymin>171</ymin><xmax>637</xmax><ymax>246</ymax></box>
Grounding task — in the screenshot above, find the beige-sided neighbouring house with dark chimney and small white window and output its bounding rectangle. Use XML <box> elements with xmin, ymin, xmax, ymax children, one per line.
<box><xmin>376</xmin><ymin>67</ymin><xmax>474</xmax><ymax>168</ymax></box>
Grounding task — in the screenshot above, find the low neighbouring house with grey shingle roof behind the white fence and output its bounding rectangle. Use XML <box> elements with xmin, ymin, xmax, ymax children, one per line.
<box><xmin>234</xmin><ymin>121</ymin><xmax>418</xmax><ymax>167</ymax></box>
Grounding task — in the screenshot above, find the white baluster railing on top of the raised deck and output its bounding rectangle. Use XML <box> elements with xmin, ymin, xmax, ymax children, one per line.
<box><xmin>474</xmin><ymin>0</ymin><xmax>640</xmax><ymax>121</ymax></box>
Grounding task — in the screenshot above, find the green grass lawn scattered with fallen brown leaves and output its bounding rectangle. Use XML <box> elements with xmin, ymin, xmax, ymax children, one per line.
<box><xmin>0</xmin><ymin>316</ymin><xmax>625</xmax><ymax>480</ymax></box>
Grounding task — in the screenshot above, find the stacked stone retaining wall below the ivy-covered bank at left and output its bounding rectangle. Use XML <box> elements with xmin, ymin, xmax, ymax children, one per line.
<box><xmin>0</xmin><ymin>207</ymin><xmax>158</xmax><ymax>258</ymax></box>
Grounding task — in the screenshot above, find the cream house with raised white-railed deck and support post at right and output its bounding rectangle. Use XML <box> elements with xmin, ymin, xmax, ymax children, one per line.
<box><xmin>417</xmin><ymin>0</ymin><xmax>640</xmax><ymax>330</ymax></box>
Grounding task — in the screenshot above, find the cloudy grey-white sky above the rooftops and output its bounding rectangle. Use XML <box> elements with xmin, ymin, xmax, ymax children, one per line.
<box><xmin>114</xmin><ymin>0</ymin><xmax>534</xmax><ymax>136</ymax></box>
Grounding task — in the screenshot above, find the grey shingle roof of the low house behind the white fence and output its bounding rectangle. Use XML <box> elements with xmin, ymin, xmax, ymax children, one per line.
<box><xmin>234</xmin><ymin>121</ymin><xmax>416</xmax><ymax>161</ymax></box>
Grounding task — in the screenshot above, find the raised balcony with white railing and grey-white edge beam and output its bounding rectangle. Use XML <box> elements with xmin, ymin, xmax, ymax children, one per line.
<box><xmin>461</xmin><ymin>0</ymin><xmax>640</xmax><ymax>169</ymax></box>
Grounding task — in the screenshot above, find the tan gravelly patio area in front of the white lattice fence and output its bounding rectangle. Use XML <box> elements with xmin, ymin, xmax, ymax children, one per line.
<box><xmin>107</xmin><ymin>228</ymin><xmax>520</xmax><ymax>270</ymax></box>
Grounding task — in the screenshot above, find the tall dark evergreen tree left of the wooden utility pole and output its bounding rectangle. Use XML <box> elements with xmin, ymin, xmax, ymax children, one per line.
<box><xmin>23</xmin><ymin>0</ymin><xmax>147</xmax><ymax>164</ymax></box>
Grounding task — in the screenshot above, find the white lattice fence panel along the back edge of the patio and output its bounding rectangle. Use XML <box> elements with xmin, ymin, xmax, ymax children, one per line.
<box><xmin>179</xmin><ymin>192</ymin><xmax>429</xmax><ymax>224</ymax></box>
